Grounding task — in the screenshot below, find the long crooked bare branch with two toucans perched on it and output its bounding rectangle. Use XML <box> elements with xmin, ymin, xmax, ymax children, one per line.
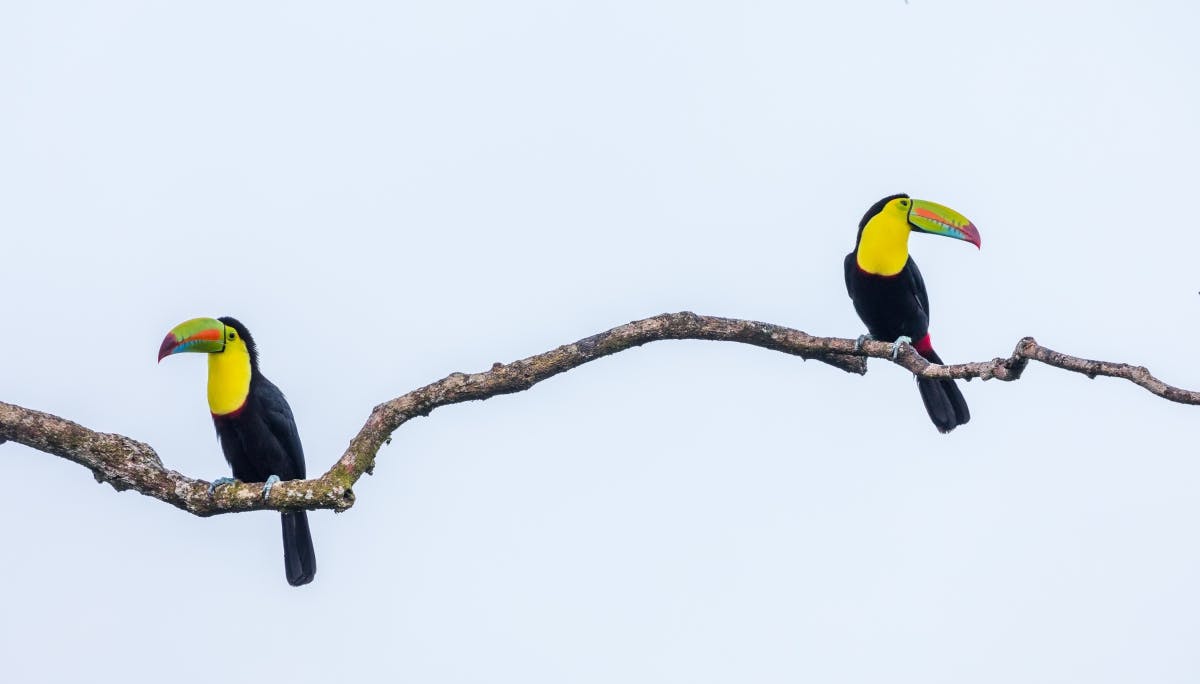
<box><xmin>0</xmin><ymin>311</ymin><xmax>1200</xmax><ymax>516</ymax></box>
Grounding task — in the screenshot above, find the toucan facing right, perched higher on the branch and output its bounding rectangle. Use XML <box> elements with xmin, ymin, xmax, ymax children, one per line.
<box><xmin>845</xmin><ymin>193</ymin><xmax>979</xmax><ymax>433</ymax></box>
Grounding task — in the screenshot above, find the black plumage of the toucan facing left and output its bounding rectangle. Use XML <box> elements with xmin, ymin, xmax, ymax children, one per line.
<box><xmin>212</xmin><ymin>317</ymin><xmax>317</xmax><ymax>587</ymax></box>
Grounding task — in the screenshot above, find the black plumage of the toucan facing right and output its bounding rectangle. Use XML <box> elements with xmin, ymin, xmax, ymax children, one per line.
<box><xmin>845</xmin><ymin>194</ymin><xmax>971</xmax><ymax>433</ymax></box>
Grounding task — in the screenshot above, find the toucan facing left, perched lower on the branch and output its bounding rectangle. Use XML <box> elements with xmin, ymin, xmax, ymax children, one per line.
<box><xmin>158</xmin><ymin>317</ymin><xmax>317</xmax><ymax>587</ymax></box>
